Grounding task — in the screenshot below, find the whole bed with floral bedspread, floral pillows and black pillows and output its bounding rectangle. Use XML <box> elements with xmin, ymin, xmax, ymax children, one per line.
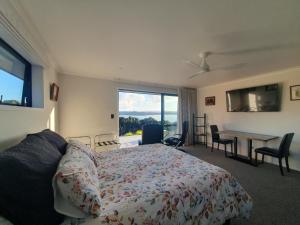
<box><xmin>0</xmin><ymin>130</ymin><xmax>252</xmax><ymax>225</ymax></box>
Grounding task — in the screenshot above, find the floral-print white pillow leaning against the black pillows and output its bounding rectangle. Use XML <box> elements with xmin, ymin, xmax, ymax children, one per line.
<box><xmin>52</xmin><ymin>142</ymin><xmax>101</xmax><ymax>218</ymax></box>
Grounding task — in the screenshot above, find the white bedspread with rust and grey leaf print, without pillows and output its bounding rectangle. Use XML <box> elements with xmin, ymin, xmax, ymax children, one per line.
<box><xmin>67</xmin><ymin>144</ymin><xmax>252</xmax><ymax>225</ymax></box>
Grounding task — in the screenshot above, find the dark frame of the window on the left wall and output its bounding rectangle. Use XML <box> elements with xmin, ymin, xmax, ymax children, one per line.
<box><xmin>0</xmin><ymin>38</ymin><xmax>32</xmax><ymax>107</ymax></box>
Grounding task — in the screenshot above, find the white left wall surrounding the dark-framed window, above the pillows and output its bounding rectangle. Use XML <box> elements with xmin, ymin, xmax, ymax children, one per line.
<box><xmin>0</xmin><ymin>1</ymin><xmax>58</xmax><ymax>150</ymax></box>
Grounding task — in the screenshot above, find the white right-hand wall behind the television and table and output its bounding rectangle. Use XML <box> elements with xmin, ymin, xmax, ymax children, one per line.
<box><xmin>198</xmin><ymin>68</ymin><xmax>300</xmax><ymax>170</ymax></box>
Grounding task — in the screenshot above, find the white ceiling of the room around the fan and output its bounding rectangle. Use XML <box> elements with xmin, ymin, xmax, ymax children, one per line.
<box><xmin>20</xmin><ymin>0</ymin><xmax>300</xmax><ymax>87</ymax></box>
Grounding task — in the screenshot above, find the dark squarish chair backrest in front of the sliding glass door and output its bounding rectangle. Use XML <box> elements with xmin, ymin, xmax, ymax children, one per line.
<box><xmin>142</xmin><ymin>124</ymin><xmax>163</xmax><ymax>145</ymax></box>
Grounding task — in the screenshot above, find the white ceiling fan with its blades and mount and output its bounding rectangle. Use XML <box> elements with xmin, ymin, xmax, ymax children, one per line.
<box><xmin>185</xmin><ymin>52</ymin><xmax>246</xmax><ymax>79</ymax></box>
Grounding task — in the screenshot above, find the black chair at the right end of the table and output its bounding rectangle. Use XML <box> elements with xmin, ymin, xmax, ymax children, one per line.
<box><xmin>255</xmin><ymin>133</ymin><xmax>294</xmax><ymax>176</ymax></box>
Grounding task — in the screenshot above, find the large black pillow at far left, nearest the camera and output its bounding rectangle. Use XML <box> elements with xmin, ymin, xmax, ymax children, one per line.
<box><xmin>0</xmin><ymin>135</ymin><xmax>63</xmax><ymax>225</ymax></box>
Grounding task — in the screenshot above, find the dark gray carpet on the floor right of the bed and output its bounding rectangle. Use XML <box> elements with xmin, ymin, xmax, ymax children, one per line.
<box><xmin>185</xmin><ymin>146</ymin><xmax>300</xmax><ymax>225</ymax></box>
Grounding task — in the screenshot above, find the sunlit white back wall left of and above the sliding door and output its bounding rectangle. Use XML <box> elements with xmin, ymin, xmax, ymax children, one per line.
<box><xmin>59</xmin><ymin>74</ymin><xmax>177</xmax><ymax>137</ymax></box>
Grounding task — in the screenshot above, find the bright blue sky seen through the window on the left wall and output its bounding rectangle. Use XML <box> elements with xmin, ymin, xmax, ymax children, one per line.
<box><xmin>0</xmin><ymin>69</ymin><xmax>23</xmax><ymax>102</ymax></box>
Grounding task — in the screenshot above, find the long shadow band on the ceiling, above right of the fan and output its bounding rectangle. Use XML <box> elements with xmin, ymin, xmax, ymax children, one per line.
<box><xmin>211</xmin><ymin>44</ymin><xmax>296</xmax><ymax>55</ymax></box>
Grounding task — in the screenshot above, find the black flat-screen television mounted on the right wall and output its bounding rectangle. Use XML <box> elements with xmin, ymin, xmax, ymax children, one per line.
<box><xmin>226</xmin><ymin>84</ymin><xmax>281</xmax><ymax>112</ymax></box>
